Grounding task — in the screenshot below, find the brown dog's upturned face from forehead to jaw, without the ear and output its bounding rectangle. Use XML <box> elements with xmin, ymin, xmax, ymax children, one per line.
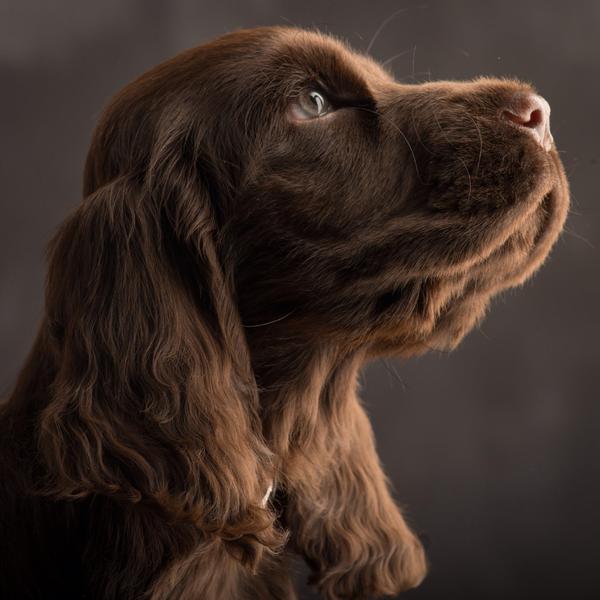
<box><xmin>84</xmin><ymin>28</ymin><xmax>568</xmax><ymax>354</ymax></box>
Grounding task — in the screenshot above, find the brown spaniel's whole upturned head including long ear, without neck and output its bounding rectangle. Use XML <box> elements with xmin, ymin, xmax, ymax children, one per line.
<box><xmin>40</xmin><ymin>28</ymin><xmax>568</xmax><ymax>556</ymax></box>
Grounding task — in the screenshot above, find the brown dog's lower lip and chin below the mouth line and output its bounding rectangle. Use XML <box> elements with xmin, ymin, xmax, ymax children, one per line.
<box><xmin>369</xmin><ymin>160</ymin><xmax>569</xmax><ymax>357</ymax></box>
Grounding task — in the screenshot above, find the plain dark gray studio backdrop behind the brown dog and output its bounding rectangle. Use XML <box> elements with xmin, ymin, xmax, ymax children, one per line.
<box><xmin>0</xmin><ymin>0</ymin><xmax>600</xmax><ymax>600</ymax></box>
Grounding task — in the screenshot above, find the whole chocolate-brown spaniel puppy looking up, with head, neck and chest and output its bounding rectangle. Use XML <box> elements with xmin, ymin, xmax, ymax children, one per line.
<box><xmin>0</xmin><ymin>27</ymin><xmax>568</xmax><ymax>600</ymax></box>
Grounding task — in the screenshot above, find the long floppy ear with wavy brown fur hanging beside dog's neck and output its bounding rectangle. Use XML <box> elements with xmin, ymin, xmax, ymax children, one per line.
<box><xmin>39</xmin><ymin>111</ymin><xmax>281</xmax><ymax>560</ymax></box>
